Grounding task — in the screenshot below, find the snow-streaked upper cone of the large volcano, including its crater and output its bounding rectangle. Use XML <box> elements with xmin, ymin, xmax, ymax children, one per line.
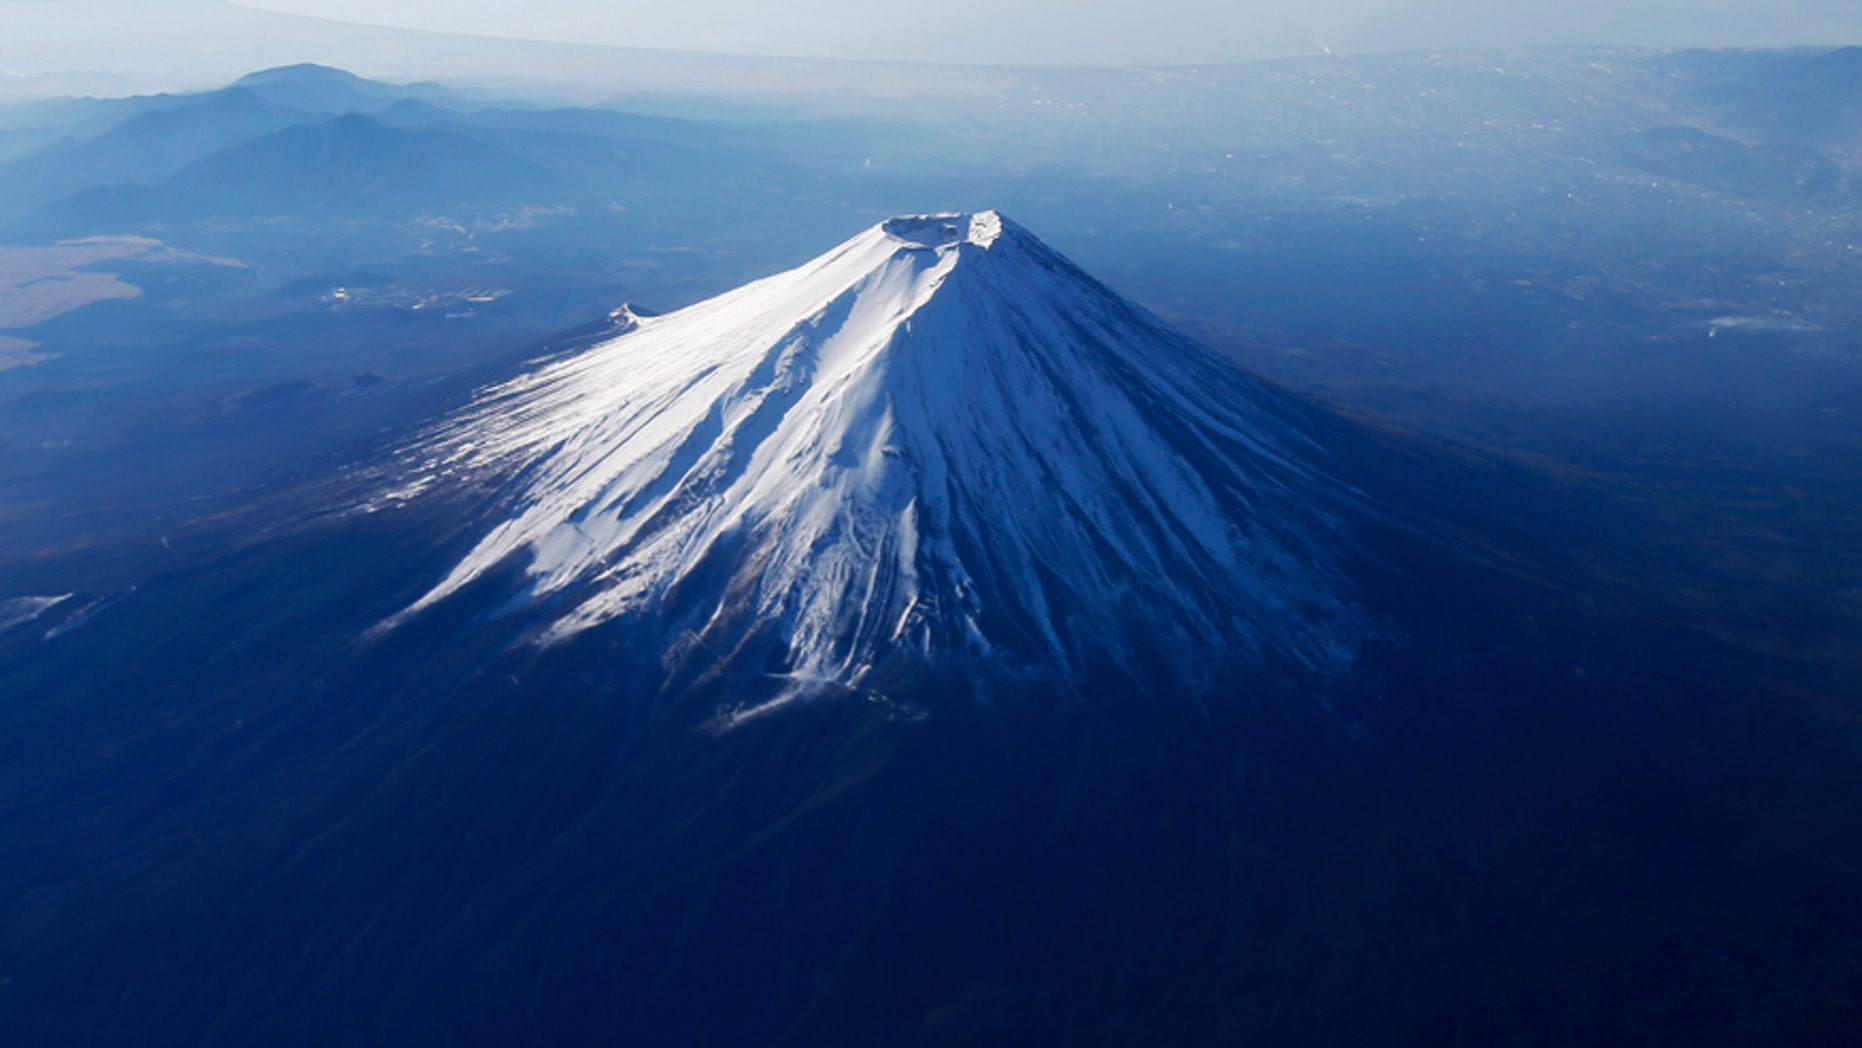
<box><xmin>384</xmin><ymin>212</ymin><xmax>1372</xmax><ymax>687</ymax></box>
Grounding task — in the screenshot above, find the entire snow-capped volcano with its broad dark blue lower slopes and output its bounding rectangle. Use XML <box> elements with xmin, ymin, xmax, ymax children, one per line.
<box><xmin>0</xmin><ymin>212</ymin><xmax>1862</xmax><ymax>1048</ymax></box>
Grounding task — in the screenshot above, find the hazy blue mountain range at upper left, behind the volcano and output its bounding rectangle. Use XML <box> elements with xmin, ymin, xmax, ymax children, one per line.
<box><xmin>0</xmin><ymin>65</ymin><xmax>778</xmax><ymax>236</ymax></box>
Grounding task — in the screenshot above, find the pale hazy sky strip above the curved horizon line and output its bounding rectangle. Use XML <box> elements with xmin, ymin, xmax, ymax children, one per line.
<box><xmin>238</xmin><ymin>0</ymin><xmax>1862</xmax><ymax>65</ymax></box>
